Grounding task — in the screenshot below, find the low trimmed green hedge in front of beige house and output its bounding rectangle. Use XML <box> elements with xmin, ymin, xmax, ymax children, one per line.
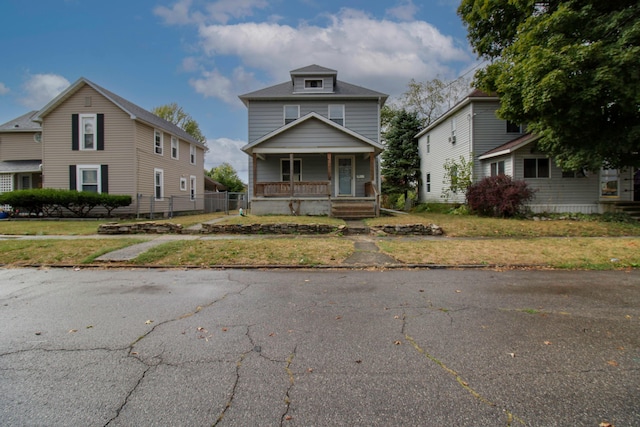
<box><xmin>0</xmin><ymin>188</ymin><xmax>131</xmax><ymax>218</ymax></box>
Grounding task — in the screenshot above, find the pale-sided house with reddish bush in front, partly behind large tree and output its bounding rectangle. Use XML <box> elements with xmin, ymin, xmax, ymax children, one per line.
<box><xmin>417</xmin><ymin>90</ymin><xmax>640</xmax><ymax>213</ymax></box>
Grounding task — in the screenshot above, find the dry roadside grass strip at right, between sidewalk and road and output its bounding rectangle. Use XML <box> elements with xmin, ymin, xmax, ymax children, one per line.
<box><xmin>378</xmin><ymin>237</ymin><xmax>640</xmax><ymax>270</ymax></box>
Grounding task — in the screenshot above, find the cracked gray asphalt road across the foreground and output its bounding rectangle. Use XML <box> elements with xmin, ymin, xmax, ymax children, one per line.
<box><xmin>0</xmin><ymin>269</ymin><xmax>640</xmax><ymax>427</ymax></box>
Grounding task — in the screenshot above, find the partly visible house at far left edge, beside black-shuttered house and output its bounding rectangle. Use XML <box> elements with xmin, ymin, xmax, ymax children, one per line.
<box><xmin>0</xmin><ymin>111</ymin><xmax>42</xmax><ymax>193</ymax></box>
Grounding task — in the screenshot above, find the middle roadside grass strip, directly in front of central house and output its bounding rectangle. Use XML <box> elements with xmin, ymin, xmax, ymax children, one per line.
<box><xmin>132</xmin><ymin>237</ymin><xmax>354</xmax><ymax>266</ymax></box>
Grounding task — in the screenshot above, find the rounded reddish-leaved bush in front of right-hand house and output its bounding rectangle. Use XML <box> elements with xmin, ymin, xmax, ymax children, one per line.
<box><xmin>466</xmin><ymin>175</ymin><xmax>535</xmax><ymax>217</ymax></box>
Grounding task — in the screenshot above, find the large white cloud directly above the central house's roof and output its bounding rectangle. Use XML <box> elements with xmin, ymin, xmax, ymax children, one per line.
<box><xmin>192</xmin><ymin>8</ymin><xmax>472</xmax><ymax>102</ymax></box>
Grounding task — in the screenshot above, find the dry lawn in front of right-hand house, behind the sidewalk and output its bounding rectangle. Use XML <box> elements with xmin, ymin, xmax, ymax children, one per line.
<box><xmin>366</xmin><ymin>212</ymin><xmax>640</xmax><ymax>237</ymax></box>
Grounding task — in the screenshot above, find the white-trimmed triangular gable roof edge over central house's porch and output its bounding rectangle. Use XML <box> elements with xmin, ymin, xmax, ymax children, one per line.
<box><xmin>242</xmin><ymin>112</ymin><xmax>384</xmax><ymax>154</ymax></box>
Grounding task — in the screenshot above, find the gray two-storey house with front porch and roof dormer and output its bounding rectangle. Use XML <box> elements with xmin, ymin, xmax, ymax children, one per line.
<box><xmin>240</xmin><ymin>65</ymin><xmax>388</xmax><ymax>218</ymax></box>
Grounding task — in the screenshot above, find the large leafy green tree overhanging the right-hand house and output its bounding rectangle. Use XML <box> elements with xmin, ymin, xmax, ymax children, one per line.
<box><xmin>458</xmin><ymin>0</ymin><xmax>640</xmax><ymax>170</ymax></box>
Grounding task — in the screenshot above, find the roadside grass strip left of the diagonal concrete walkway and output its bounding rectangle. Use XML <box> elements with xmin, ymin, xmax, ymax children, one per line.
<box><xmin>0</xmin><ymin>238</ymin><xmax>145</xmax><ymax>267</ymax></box>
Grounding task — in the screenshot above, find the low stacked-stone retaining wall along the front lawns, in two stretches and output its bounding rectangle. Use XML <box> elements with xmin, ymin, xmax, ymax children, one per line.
<box><xmin>98</xmin><ymin>221</ymin><xmax>444</xmax><ymax>236</ymax></box>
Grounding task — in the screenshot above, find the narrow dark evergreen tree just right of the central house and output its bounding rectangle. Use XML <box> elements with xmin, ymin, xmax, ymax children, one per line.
<box><xmin>382</xmin><ymin>109</ymin><xmax>421</xmax><ymax>204</ymax></box>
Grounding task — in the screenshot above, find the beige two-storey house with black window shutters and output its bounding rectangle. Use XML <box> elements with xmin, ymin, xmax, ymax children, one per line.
<box><xmin>23</xmin><ymin>78</ymin><xmax>206</xmax><ymax>215</ymax></box>
